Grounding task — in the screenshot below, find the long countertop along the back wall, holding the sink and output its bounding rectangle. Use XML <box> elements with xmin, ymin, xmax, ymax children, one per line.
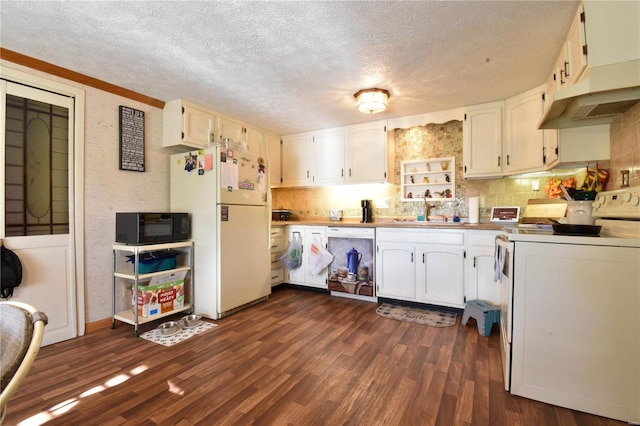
<box><xmin>271</xmin><ymin>217</ymin><xmax>504</xmax><ymax>231</ymax></box>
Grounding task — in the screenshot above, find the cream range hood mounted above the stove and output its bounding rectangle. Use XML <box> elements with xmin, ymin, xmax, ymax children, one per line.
<box><xmin>538</xmin><ymin>60</ymin><xmax>640</xmax><ymax>129</ymax></box>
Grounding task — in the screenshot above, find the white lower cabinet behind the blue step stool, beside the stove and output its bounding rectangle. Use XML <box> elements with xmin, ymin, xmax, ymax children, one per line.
<box><xmin>465</xmin><ymin>231</ymin><xmax>501</xmax><ymax>305</ymax></box>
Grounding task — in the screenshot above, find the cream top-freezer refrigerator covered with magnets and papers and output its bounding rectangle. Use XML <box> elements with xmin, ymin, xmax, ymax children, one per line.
<box><xmin>170</xmin><ymin>146</ymin><xmax>271</xmax><ymax>319</ymax></box>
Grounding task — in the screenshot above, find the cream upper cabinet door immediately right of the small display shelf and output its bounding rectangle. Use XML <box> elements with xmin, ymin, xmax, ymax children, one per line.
<box><xmin>462</xmin><ymin>102</ymin><xmax>504</xmax><ymax>178</ymax></box>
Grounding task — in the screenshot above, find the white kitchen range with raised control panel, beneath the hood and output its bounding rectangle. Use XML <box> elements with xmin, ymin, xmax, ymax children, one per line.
<box><xmin>496</xmin><ymin>187</ymin><xmax>640</xmax><ymax>423</ymax></box>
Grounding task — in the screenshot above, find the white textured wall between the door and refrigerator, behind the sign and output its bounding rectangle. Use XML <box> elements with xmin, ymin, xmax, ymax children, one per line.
<box><xmin>0</xmin><ymin>61</ymin><xmax>171</xmax><ymax>322</ymax></box>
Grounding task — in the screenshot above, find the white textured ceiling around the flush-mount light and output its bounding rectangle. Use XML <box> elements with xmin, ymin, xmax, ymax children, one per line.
<box><xmin>0</xmin><ymin>0</ymin><xmax>579</xmax><ymax>134</ymax></box>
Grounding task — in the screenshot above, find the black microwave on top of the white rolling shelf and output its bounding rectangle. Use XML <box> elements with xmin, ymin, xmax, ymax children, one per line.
<box><xmin>116</xmin><ymin>213</ymin><xmax>189</xmax><ymax>244</ymax></box>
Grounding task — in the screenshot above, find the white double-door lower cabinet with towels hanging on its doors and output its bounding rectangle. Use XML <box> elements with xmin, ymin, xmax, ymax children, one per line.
<box><xmin>287</xmin><ymin>225</ymin><xmax>327</xmax><ymax>289</ymax></box>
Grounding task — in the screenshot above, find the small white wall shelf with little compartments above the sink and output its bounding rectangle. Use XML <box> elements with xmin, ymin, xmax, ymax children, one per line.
<box><xmin>400</xmin><ymin>157</ymin><xmax>456</xmax><ymax>201</ymax></box>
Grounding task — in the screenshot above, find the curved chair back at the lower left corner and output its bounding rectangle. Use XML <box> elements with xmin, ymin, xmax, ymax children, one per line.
<box><xmin>0</xmin><ymin>301</ymin><xmax>49</xmax><ymax>424</ymax></box>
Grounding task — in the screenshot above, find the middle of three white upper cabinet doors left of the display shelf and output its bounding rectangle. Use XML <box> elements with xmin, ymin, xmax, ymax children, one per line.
<box><xmin>313</xmin><ymin>128</ymin><xmax>346</xmax><ymax>185</ymax></box>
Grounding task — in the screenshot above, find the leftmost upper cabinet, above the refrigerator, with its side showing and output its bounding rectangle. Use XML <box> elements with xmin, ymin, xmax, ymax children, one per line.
<box><xmin>162</xmin><ymin>99</ymin><xmax>216</xmax><ymax>149</ymax></box>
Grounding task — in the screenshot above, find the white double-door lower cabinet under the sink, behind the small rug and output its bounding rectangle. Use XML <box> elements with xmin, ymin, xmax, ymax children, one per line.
<box><xmin>376</xmin><ymin>228</ymin><xmax>465</xmax><ymax>308</ymax></box>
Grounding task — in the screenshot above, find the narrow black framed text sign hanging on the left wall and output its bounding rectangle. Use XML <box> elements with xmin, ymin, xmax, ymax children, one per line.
<box><xmin>120</xmin><ymin>105</ymin><xmax>144</xmax><ymax>172</ymax></box>
